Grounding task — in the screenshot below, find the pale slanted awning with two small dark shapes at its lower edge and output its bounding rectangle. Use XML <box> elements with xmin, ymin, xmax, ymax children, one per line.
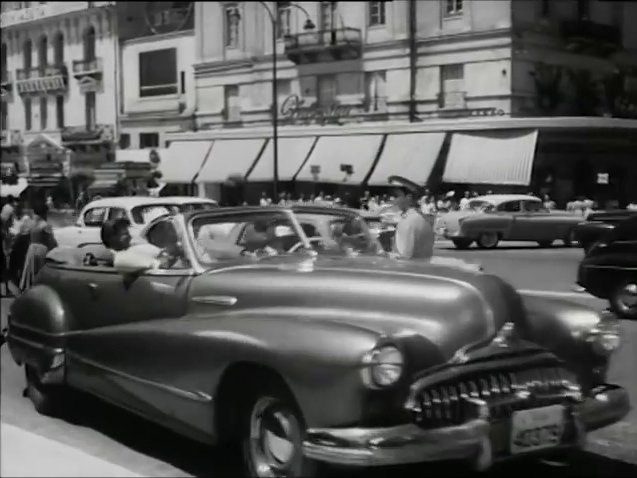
<box><xmin>296</xmin><ymin>134</ymin><xmax>383</xmax><ymax>184</ymax></box>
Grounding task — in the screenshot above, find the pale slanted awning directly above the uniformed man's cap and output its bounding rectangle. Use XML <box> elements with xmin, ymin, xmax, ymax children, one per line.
<box><xmin>368</xmin><ymin>133</ymin><xmax>445</xmax><ymax>186</ymax></box>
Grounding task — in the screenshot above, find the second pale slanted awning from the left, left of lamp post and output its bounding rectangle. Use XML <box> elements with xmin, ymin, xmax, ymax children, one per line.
<box><xmin>197</xmin><ymin>138</ymin><xmax>265</xmax><ymax>183</ymax></box>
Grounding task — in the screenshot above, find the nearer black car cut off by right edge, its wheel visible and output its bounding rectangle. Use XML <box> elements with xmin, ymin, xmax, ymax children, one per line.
<box><xmin>577</xmin><ymin>215</ymin><xmax>637</xmax><ymax>319</ymax></box>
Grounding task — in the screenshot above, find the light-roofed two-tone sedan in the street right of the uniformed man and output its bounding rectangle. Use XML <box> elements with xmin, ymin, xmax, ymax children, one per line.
<box><xmin>438</xmin><ymin>194</ymin><xmax>582</xmax><ymax>249</ymax></box>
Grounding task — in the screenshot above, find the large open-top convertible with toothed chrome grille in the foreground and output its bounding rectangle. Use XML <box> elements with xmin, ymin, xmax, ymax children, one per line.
<box><xmin>7</xmin><ymin>206</ymin><xmax>629</xmax><ymax>477</ymax></box>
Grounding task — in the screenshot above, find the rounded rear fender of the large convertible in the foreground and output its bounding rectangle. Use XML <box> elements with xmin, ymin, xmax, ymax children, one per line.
<box><xmin>7</xmin><ymin>284</ymin><xmax>72</xmax><ymax>383</ymax></box>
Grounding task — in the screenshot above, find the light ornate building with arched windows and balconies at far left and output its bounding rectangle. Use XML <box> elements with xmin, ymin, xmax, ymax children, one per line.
<box><xmin>0</xmin><ymin>2</ymin><xmax>117</xmax><ymax>200</ymax></box>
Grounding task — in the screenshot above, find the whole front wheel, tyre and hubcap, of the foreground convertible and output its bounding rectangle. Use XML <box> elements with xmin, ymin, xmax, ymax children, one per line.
<box><xmin>242</xmin><ymin>387</ymin><xmax>318</xmax><ymax>478</ymax></box>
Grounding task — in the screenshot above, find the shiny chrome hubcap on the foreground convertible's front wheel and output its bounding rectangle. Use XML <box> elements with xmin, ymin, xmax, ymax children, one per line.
<box><xmin>250</xmin><ymin>397</ymin><xmax>301</xmax><ymax>478</ymax></box>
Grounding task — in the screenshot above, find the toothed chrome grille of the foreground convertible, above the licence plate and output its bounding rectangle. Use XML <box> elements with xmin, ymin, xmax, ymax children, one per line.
<box><xmin>412</xmin><ymin>367</ymin><xmax>578</xmax><ymax>428</ymax></box>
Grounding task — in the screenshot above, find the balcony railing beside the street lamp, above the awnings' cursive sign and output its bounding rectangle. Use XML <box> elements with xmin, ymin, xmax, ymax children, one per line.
<box><xmin>285</xmin><ymin>28</ymin><xmax>363</xmax><ymax>64</ymax></box>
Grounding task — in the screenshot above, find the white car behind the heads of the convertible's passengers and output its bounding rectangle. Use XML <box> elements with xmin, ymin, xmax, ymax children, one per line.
<box><xmin>54</xmin><ymin>196</ymin><xmax>219</xmax><ymax>247</ymax></box>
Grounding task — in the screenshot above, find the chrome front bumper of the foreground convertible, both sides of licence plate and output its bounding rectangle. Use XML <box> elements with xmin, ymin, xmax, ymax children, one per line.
<box><xmin>303</xmin><ymin>385</ymin><xmax>630</xmax><ymax>470</ymax></box>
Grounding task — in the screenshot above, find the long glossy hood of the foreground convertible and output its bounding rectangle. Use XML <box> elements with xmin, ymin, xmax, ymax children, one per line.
<box><xmin>191</xmin><ymin>256</ymin><xmax>524</xmax><ymax>361</ymax></box>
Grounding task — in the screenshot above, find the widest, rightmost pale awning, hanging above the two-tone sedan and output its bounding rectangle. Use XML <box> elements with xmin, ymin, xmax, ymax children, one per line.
<box><xmin>442</xmin><ymin>130</ymin><xmax>537</xmax><ymax>186</ymax></box>
